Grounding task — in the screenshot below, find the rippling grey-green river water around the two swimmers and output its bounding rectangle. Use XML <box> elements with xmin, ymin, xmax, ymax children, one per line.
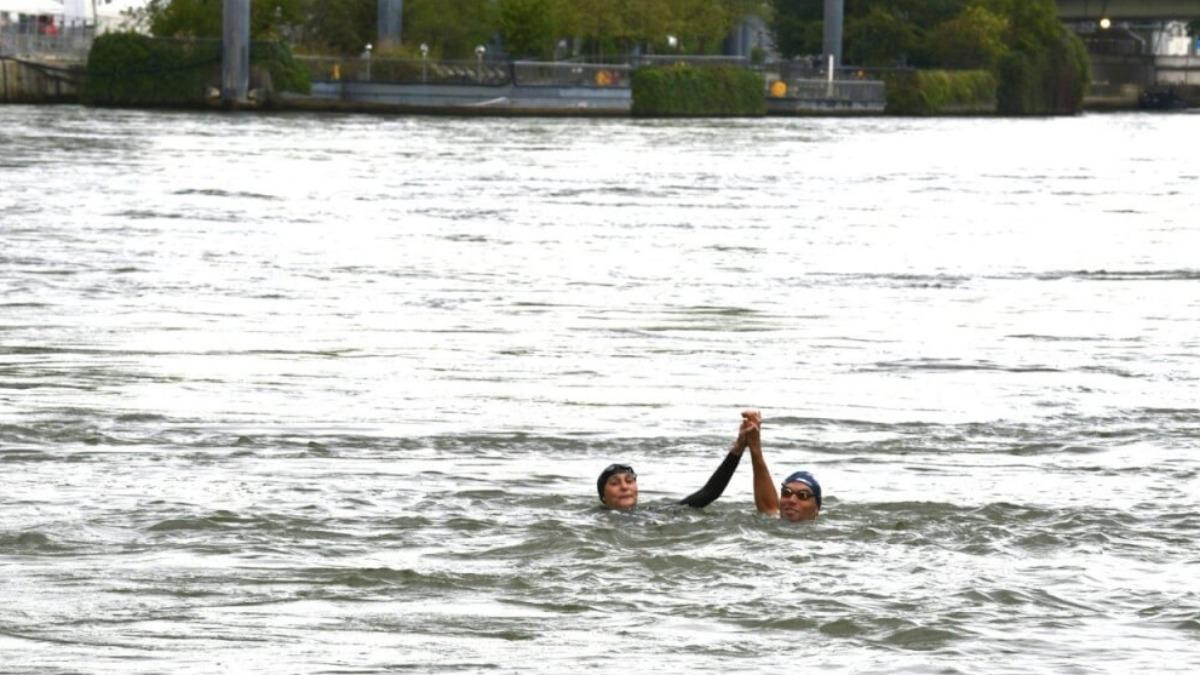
<box><xmin>0</xmin><ymin>106</ymin><xmax>1200</xmax><ymax>673</ymax></box>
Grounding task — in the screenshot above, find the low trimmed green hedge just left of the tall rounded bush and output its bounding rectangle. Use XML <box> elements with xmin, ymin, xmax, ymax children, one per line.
<box><xmin>883</xmin><ymin>70</ymin><xmax>997</xmax><ymax>115</ymax></box>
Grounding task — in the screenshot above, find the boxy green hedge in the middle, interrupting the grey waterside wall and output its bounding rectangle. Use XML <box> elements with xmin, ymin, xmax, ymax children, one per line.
<box><xmin>632</xmin><ymin>64</ymin><xmax>767</xmax><ymax>117</ymax></box>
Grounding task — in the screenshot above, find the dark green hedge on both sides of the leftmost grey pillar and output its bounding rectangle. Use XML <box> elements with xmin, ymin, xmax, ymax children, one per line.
<box><xmin>79</xmin><ymin>32</ymin><xmax>310</xmax><ymax>106</ymax></box>
